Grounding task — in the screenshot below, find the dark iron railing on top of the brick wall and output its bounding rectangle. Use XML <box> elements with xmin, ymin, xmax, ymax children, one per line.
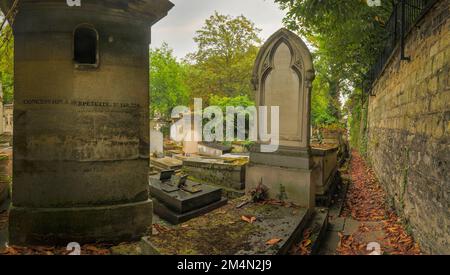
<box><xmin>363</xmin><ymin>0</ymin><xmax>439</xmax><ymax>92</ymax></box>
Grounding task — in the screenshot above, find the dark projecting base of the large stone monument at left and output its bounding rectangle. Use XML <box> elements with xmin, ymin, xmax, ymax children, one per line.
<box><xmin>9</xmin><ymin>200</ymin><xmax>153</xmax><ymax>245</ymax></box>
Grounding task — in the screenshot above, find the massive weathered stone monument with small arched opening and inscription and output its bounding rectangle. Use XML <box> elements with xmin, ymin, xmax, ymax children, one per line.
<box><xmin>0</xmin><ymin>0</ymin><xmax>173</xmax><ymax>244</ymax></box>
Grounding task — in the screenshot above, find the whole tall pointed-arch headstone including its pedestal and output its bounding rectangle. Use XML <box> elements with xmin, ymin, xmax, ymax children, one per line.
<box><xmin>246</xmin><ymin>29</ymin><xmax>315</xmax><ymax>208</ymax></box>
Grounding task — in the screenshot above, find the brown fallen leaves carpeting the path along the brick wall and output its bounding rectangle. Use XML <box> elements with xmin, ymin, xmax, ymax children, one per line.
<box><xmin>337</xmin><ymin>151</ymin><xmax>421</xmax><ymax>255</ymax></box>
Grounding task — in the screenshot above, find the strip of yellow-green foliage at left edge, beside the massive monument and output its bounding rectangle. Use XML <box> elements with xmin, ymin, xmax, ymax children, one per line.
<box><xmin>0</xmin><ymin>22</ymin><xmax>14</xmax><ymax>103</ymax></box>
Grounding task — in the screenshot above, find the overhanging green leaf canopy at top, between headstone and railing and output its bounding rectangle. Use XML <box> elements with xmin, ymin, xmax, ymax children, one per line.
<box><xmin>275</xmin><ymin>0</ymin><xmax>392</xmax><ymax>86</ymax></box>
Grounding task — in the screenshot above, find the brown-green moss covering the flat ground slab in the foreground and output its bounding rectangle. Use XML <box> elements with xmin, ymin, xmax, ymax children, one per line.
<box><xmin>150</xmin><ymin>197</ymin><xmax>302</xmax><ymax>255</ymax></box>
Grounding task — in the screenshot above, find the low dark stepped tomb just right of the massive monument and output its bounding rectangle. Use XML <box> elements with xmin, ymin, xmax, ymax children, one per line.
<box><xmin>150</xmin><ymin>177</ymin><xmax>228</xmax><ymax>224</ymax></box>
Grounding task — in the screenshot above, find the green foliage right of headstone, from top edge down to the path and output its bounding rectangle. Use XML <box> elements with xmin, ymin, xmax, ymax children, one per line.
<box><xmin>275</xmin><ymin>0</ymin><xmax>392</xmax><ymax>151</ymax></box>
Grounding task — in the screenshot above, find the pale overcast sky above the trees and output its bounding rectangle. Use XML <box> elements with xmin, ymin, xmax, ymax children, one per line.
<box><xmin>151</xmin><ymin>0</ymin><xmax>285</xmax><ymax>58</ymax></box>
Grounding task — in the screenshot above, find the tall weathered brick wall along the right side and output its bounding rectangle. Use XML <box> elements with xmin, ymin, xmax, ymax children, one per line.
<box><xmin>368</xmin><ymin>0</ymin><xmax>450</xmax><ymax>254</ymax></box>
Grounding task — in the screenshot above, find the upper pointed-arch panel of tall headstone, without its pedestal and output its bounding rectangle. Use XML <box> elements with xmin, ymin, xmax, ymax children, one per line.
<box><xmin>252</xmin><ymin>29</ymin><xmax>315</xmax><ymax>148</ymax></box>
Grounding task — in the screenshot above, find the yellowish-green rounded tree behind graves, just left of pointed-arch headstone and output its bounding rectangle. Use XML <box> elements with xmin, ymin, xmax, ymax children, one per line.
<box><xmin>187</xmin><ymin>12</ymin><xmax>261</xmax><ymax>103</ymax></box>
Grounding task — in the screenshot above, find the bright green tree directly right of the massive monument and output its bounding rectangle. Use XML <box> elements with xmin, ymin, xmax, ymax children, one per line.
<box><xmin>150</xmin><ymin>43</ymin><xmax>190</xmax><ymax>119</ymax></box>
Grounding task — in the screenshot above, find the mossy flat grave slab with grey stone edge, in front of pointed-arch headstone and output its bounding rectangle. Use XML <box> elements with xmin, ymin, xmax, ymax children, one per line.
<box><xmin>149</xmin><ymin>196</ymin><xmax>312</xmax><ymax>255</ymax></box>
